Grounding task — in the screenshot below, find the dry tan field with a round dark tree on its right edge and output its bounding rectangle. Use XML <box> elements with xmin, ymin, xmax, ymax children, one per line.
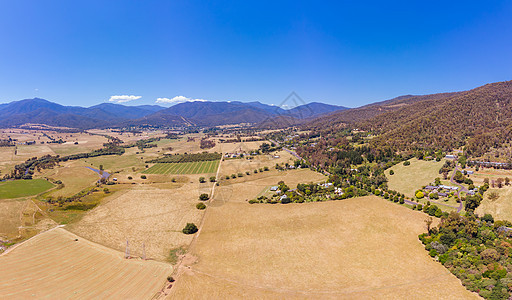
<box><xmin>69</xmin><ymin>182</ymin><xmax>211</xmax><ymax>260</ymax></box>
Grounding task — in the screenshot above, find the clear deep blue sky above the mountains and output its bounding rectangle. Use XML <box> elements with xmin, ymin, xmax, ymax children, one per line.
<box><xmin>0</xmin><ymin>0</ymin><xmax>512</xmax><ymax>107</ymax></box>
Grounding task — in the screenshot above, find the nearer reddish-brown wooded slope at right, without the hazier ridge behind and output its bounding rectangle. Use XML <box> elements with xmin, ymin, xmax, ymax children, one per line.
<box><xmin>357</xmin><ymin>81</ymin><xmax>512</xmax><ymax>155</ymax></box>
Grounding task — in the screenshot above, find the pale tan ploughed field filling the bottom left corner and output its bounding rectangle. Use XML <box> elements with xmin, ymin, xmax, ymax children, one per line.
<box><xmin>0</xmin><ymin>228</ymin><xmax>172</xmax><ymax>299</ymax></box>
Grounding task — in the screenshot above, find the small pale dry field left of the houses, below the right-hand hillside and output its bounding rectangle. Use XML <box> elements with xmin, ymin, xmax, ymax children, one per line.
<box><xmin>385</xmin><ymin>158</ymin><xmax>444</xmax><ymax>197</ymax></box>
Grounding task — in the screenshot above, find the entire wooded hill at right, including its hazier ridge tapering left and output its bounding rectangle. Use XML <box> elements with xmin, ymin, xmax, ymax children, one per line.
<box><xmin>303</xmin><ymin>81</ymin><xmax>512</xmax><ymax>157</ymax></box>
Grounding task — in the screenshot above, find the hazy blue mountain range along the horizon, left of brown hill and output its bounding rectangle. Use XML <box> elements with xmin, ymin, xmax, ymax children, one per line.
<box><xmin>0</xmin><ymin>98</ymin><xmax>346</xmax><ymax>129</ymax></box>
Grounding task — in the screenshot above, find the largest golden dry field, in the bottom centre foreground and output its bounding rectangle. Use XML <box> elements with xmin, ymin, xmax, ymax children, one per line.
<box><xmin>168</xmin><ymin>196</ymin><xmax>478</xmax><ymax>299</ymax></box>
